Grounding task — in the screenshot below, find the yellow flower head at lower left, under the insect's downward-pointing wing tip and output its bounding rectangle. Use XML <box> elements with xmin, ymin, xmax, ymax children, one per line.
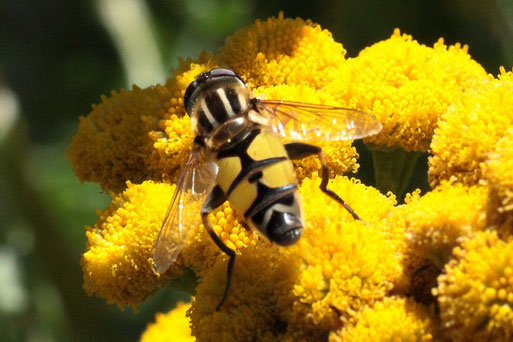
<box><xmin>81</xmin><ymin>181</ymin><xmax>173</xmax><ymax>308</ymax></box>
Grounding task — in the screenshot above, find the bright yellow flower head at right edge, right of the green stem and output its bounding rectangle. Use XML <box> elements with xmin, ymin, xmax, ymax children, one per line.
<box><xmin>429</xmin><ymin>68</ymin><xmax>513</xmax><ymax>186</ymax></box>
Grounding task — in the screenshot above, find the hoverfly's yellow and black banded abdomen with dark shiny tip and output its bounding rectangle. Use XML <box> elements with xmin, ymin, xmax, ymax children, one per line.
<box><xmin>217</xmin><ymin>127</ymin><xmax>303</xmax><ymax>245</ymax></box>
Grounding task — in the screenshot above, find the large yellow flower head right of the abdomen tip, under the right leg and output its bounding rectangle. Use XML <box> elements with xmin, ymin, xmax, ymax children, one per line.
<box><xmin>284</xmin><ymin>177</ymin><xmax>404</xmax><ymax>330</ymax></box>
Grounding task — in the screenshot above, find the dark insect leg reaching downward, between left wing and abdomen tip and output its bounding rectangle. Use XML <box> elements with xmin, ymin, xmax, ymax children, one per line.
<box><xmin>201</xmin><ymin>185</ymin><xmax>235</xmax><ymax>311</ymax></box>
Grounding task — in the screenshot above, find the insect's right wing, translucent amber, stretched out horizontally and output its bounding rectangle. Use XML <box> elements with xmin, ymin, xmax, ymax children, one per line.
<box><xmin>255</xmin><ymin>100</ymin><xmax>381</xmax><ymax>141</ymax></box>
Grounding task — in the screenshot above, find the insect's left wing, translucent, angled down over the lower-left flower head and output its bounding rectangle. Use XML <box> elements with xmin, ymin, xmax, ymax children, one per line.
<box><xmin>153</xmin><ymin>148</ymin><xmax>217</xmax><ymax>273</ymax></box>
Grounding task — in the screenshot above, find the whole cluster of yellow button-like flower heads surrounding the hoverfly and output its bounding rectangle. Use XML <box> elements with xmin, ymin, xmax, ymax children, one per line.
<box><xmin>68</xmin><ymin>14</ymin><xmax>513</xmax><ymax>341</ymax></box>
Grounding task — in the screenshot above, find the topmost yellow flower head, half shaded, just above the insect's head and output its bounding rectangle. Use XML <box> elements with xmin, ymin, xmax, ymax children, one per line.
<box><xmin>218</xmin><ymin>13</ymin><xmax>346</xmax><ymax>89</ymax></box>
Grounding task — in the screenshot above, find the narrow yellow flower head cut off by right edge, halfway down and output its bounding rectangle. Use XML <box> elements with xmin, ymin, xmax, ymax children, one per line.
<box><xmin>482</xmin><ymin>128</ymin><xmax>513</xmax><ymax>230</ymax></box>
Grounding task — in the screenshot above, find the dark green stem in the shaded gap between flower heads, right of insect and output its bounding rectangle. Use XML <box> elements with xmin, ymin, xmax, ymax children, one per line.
<box><xmin>371</xmin><ymin>147</ymin><xmax>422</xmax><ymax>199</ymax></box>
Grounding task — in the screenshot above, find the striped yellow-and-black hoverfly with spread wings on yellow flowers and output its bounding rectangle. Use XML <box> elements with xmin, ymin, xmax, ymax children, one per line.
<box><xmin>154</xmin><ymin>68</ymin><xmax>381</xmax><ymax>309</ymax></box>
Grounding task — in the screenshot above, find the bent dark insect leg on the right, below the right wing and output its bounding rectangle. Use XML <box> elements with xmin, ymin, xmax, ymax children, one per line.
<box><xmin>284</xmin><ymin>142</ymin><xmax>362</xmax><ymax>221</ymax></box>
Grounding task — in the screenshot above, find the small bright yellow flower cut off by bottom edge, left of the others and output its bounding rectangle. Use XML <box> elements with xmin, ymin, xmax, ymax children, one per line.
<box><xmin>140</xmin><ymin>302</ymin><xmax>196</xmax><ymax>342</ymax></box>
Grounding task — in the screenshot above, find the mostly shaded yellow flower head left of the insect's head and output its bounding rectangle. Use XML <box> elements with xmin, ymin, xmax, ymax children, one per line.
<box><xmin>68</xmin><ymin>54</ymin><xmax>216</xmax><ymax>192</ymax></box>
